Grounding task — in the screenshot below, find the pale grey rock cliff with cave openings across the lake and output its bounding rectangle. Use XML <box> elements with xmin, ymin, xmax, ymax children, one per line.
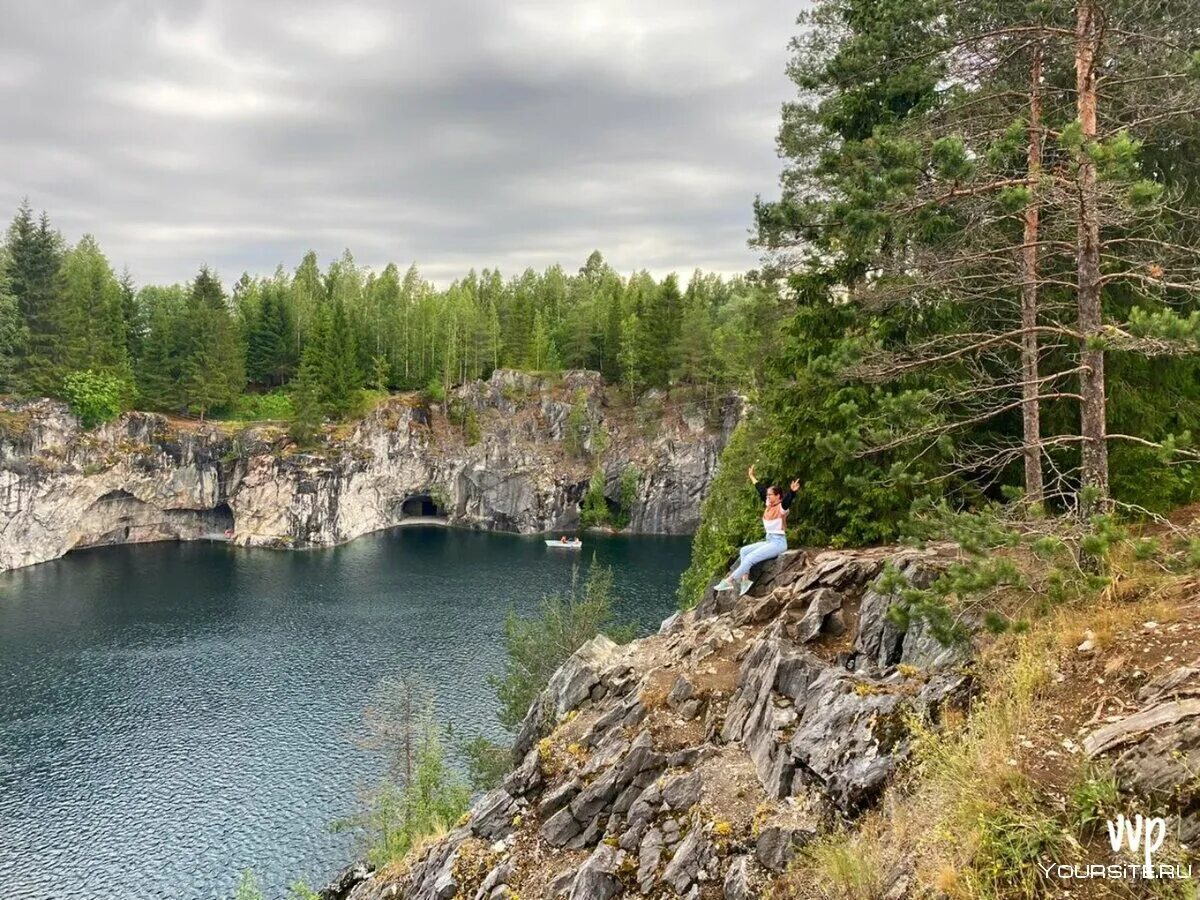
<box><xmin>0</xmin><ymin>370</ymin><xmax>740</xmax><ymax>570</ymax></box>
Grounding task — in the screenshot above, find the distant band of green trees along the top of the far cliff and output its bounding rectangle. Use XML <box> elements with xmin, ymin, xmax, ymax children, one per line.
<box><xmin>0</xmin><ymin>203</ymin><xmax>779</xmax><ymax>427</ymax></box>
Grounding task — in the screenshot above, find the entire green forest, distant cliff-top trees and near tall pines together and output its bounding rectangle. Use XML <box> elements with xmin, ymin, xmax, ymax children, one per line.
<box><xmin>0</xmin><ymin>0</ymin><xmax>1200</xmax><ymax>580</ymax></box>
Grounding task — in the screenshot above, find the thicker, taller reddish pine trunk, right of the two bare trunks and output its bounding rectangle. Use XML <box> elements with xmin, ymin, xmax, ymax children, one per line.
<box><xmin>1075</xmin><ymin>0</ymin><xmax>1109</xmax><ymax>516</ymax></box>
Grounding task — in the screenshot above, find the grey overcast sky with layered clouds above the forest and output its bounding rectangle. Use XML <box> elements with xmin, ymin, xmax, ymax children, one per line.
<box><xmin>0</xmin><ymin>0</ymin><xmax>799</xmax><ymax>283</ymax></box>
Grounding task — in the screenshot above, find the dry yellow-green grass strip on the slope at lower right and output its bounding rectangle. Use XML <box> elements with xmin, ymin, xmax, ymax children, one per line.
<box><xmin>770</xmin><ymin>565</ymin><xmax>1181</xmax><ymax>900</ymax></box>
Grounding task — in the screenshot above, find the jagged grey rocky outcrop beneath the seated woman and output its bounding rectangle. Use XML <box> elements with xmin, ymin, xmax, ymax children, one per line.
<box><xmin>333</xmin><ymin>550</ymin><xmax>971</xmax><ymax>900</ymax></box>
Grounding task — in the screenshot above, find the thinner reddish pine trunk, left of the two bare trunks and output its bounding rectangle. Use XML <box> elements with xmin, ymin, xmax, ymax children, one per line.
<box><xmin>1020</xmin><ymin>46</ymin><xmax>1045</xmax><ymax>504</ymax></box>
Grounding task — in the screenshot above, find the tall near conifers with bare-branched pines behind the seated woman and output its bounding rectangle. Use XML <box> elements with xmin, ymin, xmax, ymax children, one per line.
<box><xmin>682</xmin><ymin>0</ymin><xmax>1200</xmax><ymax>601</ymax></box>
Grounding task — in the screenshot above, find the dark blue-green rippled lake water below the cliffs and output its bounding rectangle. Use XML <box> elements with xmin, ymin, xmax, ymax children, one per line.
<box><xmin>0</xmin><ymin>528</ymin><xmax>689</xmax><ymax>900</ymax></box>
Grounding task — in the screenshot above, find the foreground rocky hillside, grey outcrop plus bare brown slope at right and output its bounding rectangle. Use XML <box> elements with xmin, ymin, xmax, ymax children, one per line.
<box><xmin>320</xmin><ymin>546</ymin><xmax>1200</xmax><ymax>900</ymax></box>
